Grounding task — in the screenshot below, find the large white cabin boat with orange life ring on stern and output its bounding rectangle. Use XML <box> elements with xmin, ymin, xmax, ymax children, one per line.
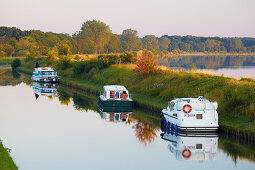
<box><xmin>161</xmin><ymin>96</ymin><xmax>219</xmax><ymax>132</ymax></box>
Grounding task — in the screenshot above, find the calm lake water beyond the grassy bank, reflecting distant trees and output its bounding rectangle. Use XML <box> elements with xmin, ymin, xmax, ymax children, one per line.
<box><xmin>159</xmin><ymin>56</ymin><xmax>255</xmax><ymax>79</ymax></box>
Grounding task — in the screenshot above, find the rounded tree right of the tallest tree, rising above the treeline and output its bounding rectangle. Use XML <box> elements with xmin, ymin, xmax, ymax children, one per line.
<box><xmin>120</xmin><ymin>29</ymin><xmax>141</xmax><ymax>51</ymax></box>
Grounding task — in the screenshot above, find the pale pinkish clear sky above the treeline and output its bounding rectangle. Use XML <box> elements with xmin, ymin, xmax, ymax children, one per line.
<box><xmin>0</xmin><ymin>0</ymin><xmax>255</xmax><ymax>37</ymax></box>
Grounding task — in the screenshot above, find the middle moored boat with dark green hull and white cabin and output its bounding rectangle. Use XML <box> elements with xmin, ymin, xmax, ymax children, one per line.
<box><xmin>98</xmin><ymin>85</ymin><xmax>134</xmax><ymax>112</ymax></box>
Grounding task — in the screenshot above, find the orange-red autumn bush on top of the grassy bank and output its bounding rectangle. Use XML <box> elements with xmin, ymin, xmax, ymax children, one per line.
<box><xmin>137</xmin><ymin>50</ymin><xmax>158</xmax><ymax>74</ymax></box>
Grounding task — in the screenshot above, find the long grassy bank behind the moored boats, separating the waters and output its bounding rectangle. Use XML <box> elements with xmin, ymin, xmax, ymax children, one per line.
<box><xmin>17</xmin><ymin>58</ymin><xmax>255</xmax><ymax>136</ymax></box>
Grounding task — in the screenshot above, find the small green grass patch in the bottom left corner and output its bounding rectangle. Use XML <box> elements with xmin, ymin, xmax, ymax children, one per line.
<box><xmin>0</xmin><ymin>142</ymin><xmax>18</xmax><ymax>170</ymax></box>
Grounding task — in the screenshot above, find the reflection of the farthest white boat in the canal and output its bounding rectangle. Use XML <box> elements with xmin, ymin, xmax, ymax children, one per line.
<box><xmin>32</xmin><ymin>82</ymin><xmax>57</xmax><ymax>100</ymax></box>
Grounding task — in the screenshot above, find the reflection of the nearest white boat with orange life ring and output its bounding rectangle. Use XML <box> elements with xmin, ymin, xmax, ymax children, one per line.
<box><xmin>161</xmin><ymin>121</ymin><xmax>218</xmax><ymax>162</ymax></box>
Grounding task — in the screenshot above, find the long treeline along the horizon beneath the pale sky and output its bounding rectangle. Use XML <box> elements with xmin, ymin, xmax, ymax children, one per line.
<box><xmin>0</xmin><ymin>20</ymin><xmax>255</xmax><ymax>56</ymax></box>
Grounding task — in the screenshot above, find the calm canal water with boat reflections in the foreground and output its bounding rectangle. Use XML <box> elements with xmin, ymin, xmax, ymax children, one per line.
<box><xmin>0</xmin><ymin>69</ymin><xmax>255</xmax><ymax>170</ymax></box>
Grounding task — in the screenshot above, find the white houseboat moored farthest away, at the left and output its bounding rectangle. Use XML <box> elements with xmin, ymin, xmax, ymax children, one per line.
<box><xmin>32</xmin><ymin>67</ymin><xmax>58</xmax><ymax>82</ymax></box>
